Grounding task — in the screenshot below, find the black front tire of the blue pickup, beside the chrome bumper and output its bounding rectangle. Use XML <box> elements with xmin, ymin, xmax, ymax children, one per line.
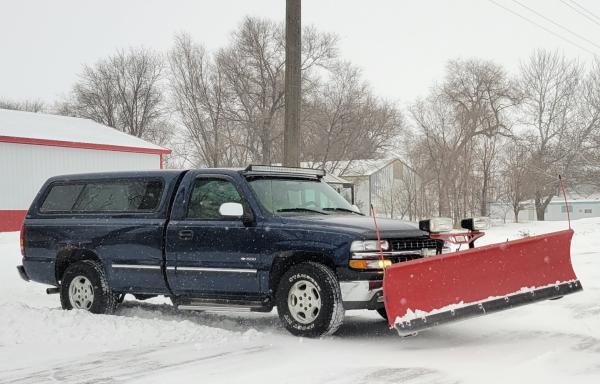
<box><xmin>276</xmin><ymin>262</ymin><xmax>344</xmax><ymax>337</ymax></box>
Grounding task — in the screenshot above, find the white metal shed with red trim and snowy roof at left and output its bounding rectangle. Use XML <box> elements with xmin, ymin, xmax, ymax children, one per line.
<box><xmin>0</xmin><ymin>109</ymin><xmax>171</xmax><ymax>232</ymax></box>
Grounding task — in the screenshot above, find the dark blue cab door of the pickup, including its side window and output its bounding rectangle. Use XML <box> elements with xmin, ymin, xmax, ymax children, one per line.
<box><xmin>167</xmin><ymin>175</ymin><xmax>260</xmax><ymax>296</ymax></box>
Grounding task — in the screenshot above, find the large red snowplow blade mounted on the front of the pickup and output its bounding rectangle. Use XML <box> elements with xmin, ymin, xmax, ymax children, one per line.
<box><xmin>383</xmin><ymin>229</ymin><xmax>582</xmax><ymax>335</ymax></box>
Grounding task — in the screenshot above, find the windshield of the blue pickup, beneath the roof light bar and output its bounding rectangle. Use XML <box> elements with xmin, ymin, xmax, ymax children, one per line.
<box><xmin>250</xmin><ymin>179</ymin><xmax>360</xmax><ymax>215</ymax></box>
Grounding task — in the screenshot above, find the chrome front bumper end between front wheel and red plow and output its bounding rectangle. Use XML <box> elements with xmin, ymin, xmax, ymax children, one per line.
<box><xmin>340</xmin><ymin>280</ymin><xmax>383</xmax><ymax>309</ymax></box>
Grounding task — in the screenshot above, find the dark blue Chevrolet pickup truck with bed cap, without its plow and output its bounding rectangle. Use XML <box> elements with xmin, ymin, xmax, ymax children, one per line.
<box><xmin>17</xmin><ymin>166</ymin><xmax>443</xmax><ymax>337</ymax></box>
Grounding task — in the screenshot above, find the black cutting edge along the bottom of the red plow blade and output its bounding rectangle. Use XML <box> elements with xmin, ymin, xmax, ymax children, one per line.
<box><xmin>394</xmin><ymin>280</ymin><xmax>583</xmax><ymax>336</ymax></box>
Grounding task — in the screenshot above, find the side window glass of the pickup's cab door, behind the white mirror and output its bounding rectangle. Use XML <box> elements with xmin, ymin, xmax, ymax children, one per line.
<box><xmin>187</xmin><ymin>179</ymin><xmax>242</xmax><ymax>220</ymax></box>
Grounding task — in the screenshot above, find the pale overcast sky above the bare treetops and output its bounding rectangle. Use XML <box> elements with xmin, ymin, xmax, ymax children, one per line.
<box><xmin>0</xmin><ymin>0</ymin><xmax>600</xmax><ymax>104</ymax></box>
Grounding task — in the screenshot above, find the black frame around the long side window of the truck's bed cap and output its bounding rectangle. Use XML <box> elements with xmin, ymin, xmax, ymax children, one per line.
<box><xmin>36</xmin><ymin>176</ymin><xmax>166</xmax><ymax>216</ymax></box>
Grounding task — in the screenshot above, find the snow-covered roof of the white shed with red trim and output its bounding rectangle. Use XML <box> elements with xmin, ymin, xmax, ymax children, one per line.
<box><xmin>0</xmin><ymin>109</ymin><xmax>170</xmax><ymax>153</ymax></box>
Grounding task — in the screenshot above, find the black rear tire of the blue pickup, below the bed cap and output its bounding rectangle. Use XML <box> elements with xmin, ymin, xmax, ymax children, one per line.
<box><xmin>60</xmin><ymin>260</ymin><xmax>117</xmax><ymax>314</ymax></box>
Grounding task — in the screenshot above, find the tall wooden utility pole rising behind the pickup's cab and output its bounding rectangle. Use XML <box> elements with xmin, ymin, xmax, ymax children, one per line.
<box><xmin>283</xmin><ymin>0</ymin><xmax>302</xmax><ymax>167</ymax></box>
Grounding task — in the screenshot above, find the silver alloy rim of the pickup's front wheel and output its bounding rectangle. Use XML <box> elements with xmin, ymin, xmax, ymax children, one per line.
<box><xmin>288</xmin><ymin>280</ymin><xmax>321</xmax><ymax>324</ymax></box>
